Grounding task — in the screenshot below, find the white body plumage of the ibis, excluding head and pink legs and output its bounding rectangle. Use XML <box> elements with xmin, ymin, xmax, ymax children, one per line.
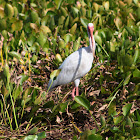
<box><xmin>48</xmin><ymin>47</ymin><xmax>93</xmax><ymax>88</ymax></box>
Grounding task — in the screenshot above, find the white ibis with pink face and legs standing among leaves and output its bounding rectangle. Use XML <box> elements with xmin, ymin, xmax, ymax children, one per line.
<box><xmin>48</xmin><ymin>23</ymin><xmax>96</xmax><ymax>99</ymax></box>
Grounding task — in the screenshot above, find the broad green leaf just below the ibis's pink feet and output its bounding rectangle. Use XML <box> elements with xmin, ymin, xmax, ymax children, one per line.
<box><xmin>74</xmin><ymin>96</ymin><xmax>90</xmax><ymax>110</ymax></box>
